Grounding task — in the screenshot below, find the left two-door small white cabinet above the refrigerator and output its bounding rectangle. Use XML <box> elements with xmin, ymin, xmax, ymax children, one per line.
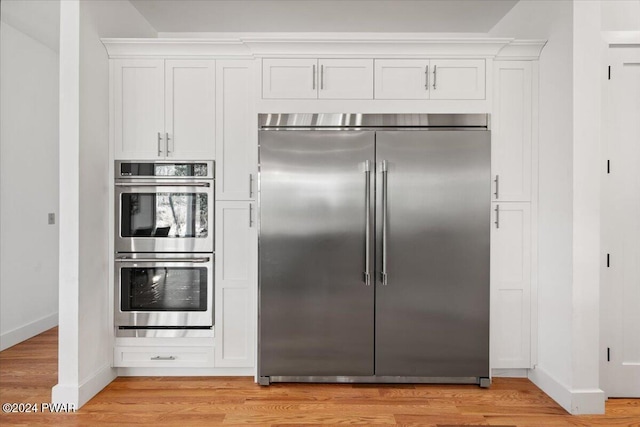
<box><xmin>262</xmin><ymin>59</ymin><xmax>373</xmax><ymax>99</ymax></box>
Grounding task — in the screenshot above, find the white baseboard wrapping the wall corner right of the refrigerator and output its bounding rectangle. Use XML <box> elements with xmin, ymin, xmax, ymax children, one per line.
<box><xmin>529</xmin><ymin>367</ymin><xmax>605</xmax><ymax>415</ymax></box>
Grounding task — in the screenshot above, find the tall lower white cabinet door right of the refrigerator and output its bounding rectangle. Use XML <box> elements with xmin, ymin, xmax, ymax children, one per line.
<box><xmin>490</xmin><ymin>203</ymin><xmax>531</xmax><ymax>369</ymax></box>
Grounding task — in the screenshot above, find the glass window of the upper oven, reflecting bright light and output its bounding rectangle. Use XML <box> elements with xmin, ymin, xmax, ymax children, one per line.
<box><xmin>120</xmin><ymin>193</ymin><xmax>209</xmax><ymax>238</ymax></box>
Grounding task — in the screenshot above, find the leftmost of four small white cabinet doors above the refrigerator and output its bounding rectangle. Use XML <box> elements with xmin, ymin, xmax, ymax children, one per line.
<box><xmin>262</xmin><ymin>59</ymin><xmax>318</xmax><ymax>99</ymax></box>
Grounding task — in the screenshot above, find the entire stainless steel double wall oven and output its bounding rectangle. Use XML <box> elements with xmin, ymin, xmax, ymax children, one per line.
<box><xmin>114</xmin><ymin>161</ymin><xmax>215</xmax><ymax>336</ymax></box>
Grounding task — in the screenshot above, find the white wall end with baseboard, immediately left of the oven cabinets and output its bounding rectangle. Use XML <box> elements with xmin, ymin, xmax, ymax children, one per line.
<box><xmin>53</xmin><ymin>0</ymin><xmax>157</xmax><ymax>406</ymax></box>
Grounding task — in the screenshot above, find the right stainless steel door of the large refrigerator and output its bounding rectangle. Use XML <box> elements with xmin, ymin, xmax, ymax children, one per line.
<box><xmin>375</xmin><ymin>130</ymin><xmax>491</xmax><ymax>377</ymax></box>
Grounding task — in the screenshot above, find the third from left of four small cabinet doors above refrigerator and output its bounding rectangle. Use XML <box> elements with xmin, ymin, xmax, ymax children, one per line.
<box><xmin>375</xmin><ymin>59</ymin><xmax>430</xmax><ymax>99</ymax></box>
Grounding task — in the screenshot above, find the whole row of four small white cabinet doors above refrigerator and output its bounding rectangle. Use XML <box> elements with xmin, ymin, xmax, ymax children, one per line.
<box><xmin>262</xmin><ymin>59</ymin><xmax>486</xmax><ymax>100</ymax></box>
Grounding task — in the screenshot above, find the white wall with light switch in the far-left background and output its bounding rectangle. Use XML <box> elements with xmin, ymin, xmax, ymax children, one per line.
<box><xmin>0</xmin><ymin>1</ymin><xmax>58</xmax><ymax>350</ymax></box>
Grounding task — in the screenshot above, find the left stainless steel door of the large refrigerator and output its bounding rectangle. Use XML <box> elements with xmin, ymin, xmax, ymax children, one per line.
<box><xmin>258</xmin><ymin>130</ymin><xmax>375</xmax><ymax>376</ymax></box>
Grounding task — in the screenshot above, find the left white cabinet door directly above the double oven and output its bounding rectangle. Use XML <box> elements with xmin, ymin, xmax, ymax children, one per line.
<box><xmin>113</xmin><ymin>59</ymin><xmax>166</xmax><ymax>160</ymax></box>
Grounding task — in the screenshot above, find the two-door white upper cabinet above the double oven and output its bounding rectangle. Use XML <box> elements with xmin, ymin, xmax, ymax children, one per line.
<box><xmin>113</xmin><ymin>59</ymin><xmax>215</xmax><ymax>160</ymax></box>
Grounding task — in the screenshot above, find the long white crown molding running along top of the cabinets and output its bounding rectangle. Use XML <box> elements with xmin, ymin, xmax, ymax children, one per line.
<box><xmin>102</xmin><ymin>33</ymin><xmax>546</xmax><ymax>59</ymax></box>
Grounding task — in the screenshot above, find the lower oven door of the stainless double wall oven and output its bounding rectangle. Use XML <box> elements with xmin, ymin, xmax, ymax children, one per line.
<box><xmin>114</xmin><ymin>253</ymin><xmax>214</xmax><ymax>330</ymax></box>
